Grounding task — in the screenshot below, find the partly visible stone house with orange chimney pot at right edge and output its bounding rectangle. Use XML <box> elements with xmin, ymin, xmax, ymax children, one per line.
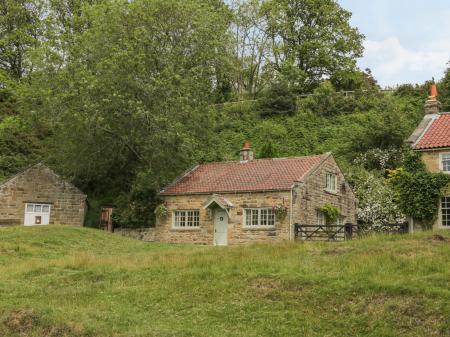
<box><xmin>407</xmin><ymin>84</ymin><xmax>450</xmax><ymax>229</ymax></box>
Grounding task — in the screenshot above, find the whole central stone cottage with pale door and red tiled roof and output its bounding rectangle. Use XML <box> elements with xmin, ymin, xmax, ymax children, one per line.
<box><xmin>153</xmin><ymin>143</ymin><xmax>356</xmax><ymax>245</ymax></box>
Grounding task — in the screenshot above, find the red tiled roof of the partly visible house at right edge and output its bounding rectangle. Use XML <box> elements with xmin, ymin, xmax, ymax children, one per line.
<box><xmin>414</xmin><ymin>113</ymin><xmax>450</xmax><ymax>149</ymax></box>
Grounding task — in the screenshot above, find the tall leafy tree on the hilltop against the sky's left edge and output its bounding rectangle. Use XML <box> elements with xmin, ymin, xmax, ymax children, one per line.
<box><xmin>263</xmin><ymin>0</ymin><xmax>363</xmax><ymax>91</ymax></box>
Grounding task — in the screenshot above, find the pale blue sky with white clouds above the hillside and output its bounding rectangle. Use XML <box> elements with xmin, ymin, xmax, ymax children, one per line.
<box><xmin>338</xmin><ymin>0</ymin><xmax>450</xmax><ymax>87</ymax></box>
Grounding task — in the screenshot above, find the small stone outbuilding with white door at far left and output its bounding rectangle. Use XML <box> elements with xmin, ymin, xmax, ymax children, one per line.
<box><xmin>0</xmin><ymin>164</ymin><xmax>86</xmax><ymax>226</ymax></box>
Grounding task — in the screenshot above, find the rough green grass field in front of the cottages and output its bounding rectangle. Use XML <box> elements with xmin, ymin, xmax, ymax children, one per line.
<box><xmin>0</xmin><ymin>226</ymin><xmax>450</xmax><ymax>337</ymax></box>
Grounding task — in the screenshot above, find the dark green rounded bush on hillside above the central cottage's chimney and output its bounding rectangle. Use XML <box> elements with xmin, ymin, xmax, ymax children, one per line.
<box><xmin>258</xmin><ymin>82</ymin><xmax>297</xmax><ymax>118</ymax></box>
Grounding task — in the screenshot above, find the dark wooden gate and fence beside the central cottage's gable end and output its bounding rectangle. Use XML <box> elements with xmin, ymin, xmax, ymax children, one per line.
<box><xmin>294</xmin><ymin>223</ymin><xmax>408</xmax><ymax>241</ymax></box>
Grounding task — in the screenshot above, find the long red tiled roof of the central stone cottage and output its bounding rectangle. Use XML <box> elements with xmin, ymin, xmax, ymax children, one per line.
<box><xmin>161</xmin><ymin>155</ymin><xmax>327</xmax><ymax>195</ymax></box>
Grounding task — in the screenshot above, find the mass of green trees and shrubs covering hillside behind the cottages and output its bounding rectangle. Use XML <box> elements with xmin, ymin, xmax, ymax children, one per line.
<box><xmin>0</xmin><ymin>0</ymin><xmax>444</xmax><ymax>226</ymax></box>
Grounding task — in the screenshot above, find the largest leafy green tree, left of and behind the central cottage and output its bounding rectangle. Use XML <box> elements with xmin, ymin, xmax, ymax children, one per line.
<box><xmin>26</xmin><ymin>0</ymin><xmax>230</xmax><ymax>223</ymax></box>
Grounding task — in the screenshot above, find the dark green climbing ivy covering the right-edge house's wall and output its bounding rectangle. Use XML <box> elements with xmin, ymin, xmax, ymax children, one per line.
<box><xmin>390</xmin><ymin>153</ymin><xmax>450</xmax><ymax>229</ymax></box>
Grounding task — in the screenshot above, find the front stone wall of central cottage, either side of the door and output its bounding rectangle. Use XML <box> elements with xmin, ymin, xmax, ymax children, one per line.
<box><xmin>155</xmin><ymin>191</ymin><xmax>290</xmax><ymax>245</ymax></box>
